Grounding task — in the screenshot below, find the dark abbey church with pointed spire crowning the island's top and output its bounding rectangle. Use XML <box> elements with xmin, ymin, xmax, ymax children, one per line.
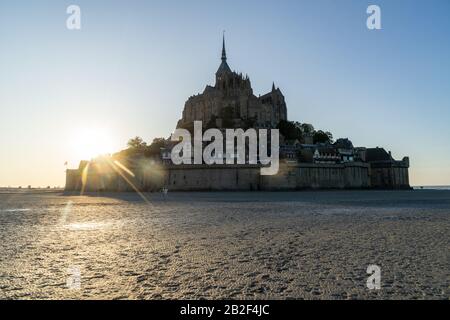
<box><xmin>177</xmin><ymin>38</ymin><xmax>287</xmax><ymax>129</ymax></box>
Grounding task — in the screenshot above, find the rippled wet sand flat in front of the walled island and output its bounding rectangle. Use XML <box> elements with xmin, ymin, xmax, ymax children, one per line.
<box><xmin>0</xmin><ymin>190</ymin><xmax>450</xmax><ymax>299</ymax></box>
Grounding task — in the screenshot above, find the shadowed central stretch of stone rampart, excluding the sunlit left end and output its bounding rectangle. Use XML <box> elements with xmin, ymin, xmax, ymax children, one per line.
<box><xmin>165</xmin><ymin>163</ymin><xmax>370</xmax><ymax>191</ymax></box>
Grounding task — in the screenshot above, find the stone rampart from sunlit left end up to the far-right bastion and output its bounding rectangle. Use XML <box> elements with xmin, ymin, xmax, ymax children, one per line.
<box><xmin>66</xmin><ymin>162</ymin><xmax>382</xmax><ymax>192</ymax></box>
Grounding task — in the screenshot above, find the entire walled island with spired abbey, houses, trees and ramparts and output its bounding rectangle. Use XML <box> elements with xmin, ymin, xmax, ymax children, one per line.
<box><xmin>66</xmin><ymin>38</ymin><xmax>410</xmax><ymax>192</ymax></box>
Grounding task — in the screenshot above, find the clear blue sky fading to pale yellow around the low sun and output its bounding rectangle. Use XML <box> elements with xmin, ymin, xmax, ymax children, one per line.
<box><xmin>0</xmin><ymin>0</ymin><xmax>450</xmax><ymax>186</ymax></box>
